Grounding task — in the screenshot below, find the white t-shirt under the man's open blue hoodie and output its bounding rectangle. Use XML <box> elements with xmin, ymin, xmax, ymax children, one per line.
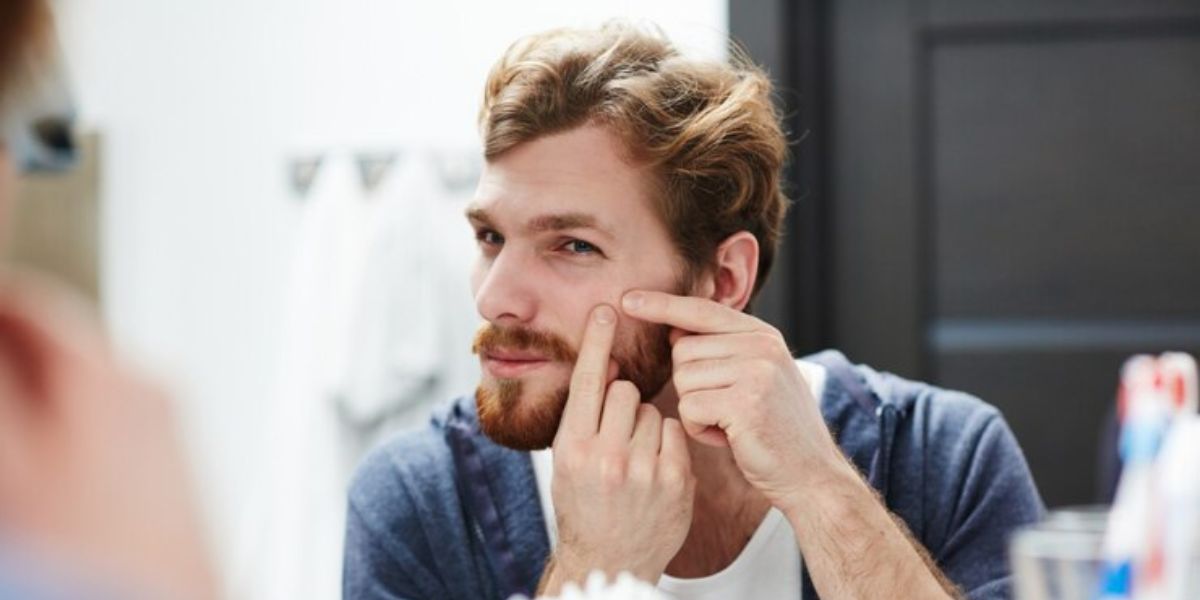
<box><xmin>530</xmin><ymin>360</ymin><xmax>827</xmax><ymax>600</ymax></box>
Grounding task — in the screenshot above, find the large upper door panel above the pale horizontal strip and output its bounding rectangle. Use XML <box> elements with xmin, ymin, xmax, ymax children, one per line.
<box><xmin>929</xmin><ymin>37</ymin><xmax>1200</xmax><ymax>319</ymax></box>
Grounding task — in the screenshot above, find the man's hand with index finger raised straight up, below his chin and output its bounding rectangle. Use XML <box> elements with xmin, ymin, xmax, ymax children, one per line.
<box><xmin>541</xmin><ymin>305</ymin><xmax>695</xmax><ymax>594</ymax></box>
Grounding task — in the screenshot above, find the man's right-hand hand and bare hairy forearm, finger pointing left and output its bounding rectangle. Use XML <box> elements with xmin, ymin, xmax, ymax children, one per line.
<box><xmin>623</xmin><ymin>292</ymin><xmax>956</xmax><ymax>598</ymax></box>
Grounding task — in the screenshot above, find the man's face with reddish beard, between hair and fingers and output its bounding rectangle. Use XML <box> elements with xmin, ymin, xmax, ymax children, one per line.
<box><xmin>467</xmin><ymin>126</ymin><xmax>685</xmax><ymax>450</ymax></box>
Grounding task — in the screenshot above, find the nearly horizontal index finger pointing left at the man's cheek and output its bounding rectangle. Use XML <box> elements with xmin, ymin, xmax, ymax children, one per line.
<box><xmin>622</xmin><ymin>290</ymin><xmax>762</xmax><ymax>334</ymax></box>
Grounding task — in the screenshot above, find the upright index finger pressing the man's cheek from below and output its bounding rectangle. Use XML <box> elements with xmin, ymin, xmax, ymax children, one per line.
<box><xmin>562</xmin><ymin>305</ymin><xmax>617</xmax><ymax>436</ymax></box>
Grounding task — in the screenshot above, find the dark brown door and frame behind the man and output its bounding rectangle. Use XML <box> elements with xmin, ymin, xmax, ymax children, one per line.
<box><xmin>731</xmin><ymin>0</ymin><xmax>1200</xmax><ymax>505</ymax></box>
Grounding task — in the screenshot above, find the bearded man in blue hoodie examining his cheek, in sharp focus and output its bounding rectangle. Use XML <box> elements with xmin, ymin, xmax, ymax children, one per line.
<box><xmin>344</xmin><ymin>24</ymin><xmax>1042</xmax><ymax>599</ymax></box>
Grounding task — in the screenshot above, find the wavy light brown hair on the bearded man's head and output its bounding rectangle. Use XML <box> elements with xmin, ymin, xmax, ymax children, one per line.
<box><xmin>480</xmin><ymin>22</ymin><xmax>787</xmax><ymax>304</ymax></box>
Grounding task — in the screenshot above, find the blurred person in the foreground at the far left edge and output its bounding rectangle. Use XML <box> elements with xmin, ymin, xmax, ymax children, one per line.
<box><xmin>0</xmin><ymin>0</ymin><xmax>217</xmax><ymax>600</ymax></box>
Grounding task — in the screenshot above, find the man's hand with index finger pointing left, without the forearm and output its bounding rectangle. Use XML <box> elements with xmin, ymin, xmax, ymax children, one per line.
<box><xmin>623</xmin><ymin>292</ymin><xmax>848</xmax><ymax>512</ymax></box>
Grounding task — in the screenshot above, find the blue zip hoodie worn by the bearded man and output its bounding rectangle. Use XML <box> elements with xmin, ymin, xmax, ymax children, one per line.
<box><xmin>342</xmin><ymin>350</ymin><xmax>1043</xmax><ymax>600</ymax></box>
